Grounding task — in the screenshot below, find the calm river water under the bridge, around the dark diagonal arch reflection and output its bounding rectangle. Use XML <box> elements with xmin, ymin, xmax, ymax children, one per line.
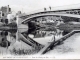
<box><xmin>0</xmin><ymin>20</ymin><xmax>69</xmax><ymax>54</ymax></box>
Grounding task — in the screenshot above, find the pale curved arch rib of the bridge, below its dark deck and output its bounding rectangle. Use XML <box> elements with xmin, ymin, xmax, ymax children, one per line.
<box><xmin>22</xmin><ymin>12</ymin><xmax>80</xmax><ymax>23</ymax></box>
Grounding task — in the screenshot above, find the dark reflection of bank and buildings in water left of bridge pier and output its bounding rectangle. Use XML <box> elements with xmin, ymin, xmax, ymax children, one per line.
<box><xmin>0</xmin><ymin>23</ymin><xmax>17</xmax><ymax>47</ymax></box>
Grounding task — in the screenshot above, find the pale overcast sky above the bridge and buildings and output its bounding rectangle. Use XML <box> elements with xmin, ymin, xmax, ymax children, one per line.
<box><xmin>0</xmin><ymin>0</ymin><xmax>80</xmax><ymax>12</ymax></box>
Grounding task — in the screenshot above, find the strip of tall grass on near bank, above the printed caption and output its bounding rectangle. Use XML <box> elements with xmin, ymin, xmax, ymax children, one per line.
<box><xmin>10</xmin><ymin>48</ymin><xmax>38</xmax><ymax>55</ymax></box>
